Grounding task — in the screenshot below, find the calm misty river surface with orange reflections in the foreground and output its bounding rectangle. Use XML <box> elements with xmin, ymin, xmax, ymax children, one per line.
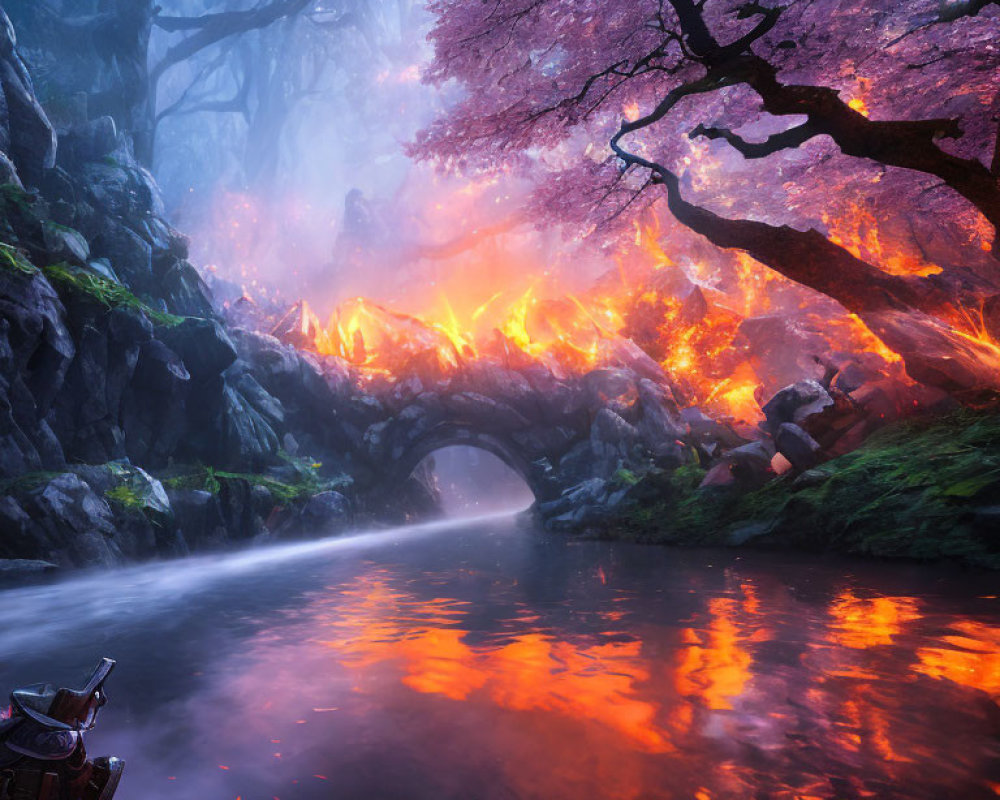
<box><xmin>0</xmin><ymin>518</ymin><xmax>1000</xmax><ymax>800</ymax></box>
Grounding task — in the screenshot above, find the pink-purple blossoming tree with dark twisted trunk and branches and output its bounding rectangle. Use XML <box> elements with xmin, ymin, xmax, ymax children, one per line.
<box><xmin>412</xmin><ymin>0</ymin><xmax>1000</xmax><ymax>391</ymax></box>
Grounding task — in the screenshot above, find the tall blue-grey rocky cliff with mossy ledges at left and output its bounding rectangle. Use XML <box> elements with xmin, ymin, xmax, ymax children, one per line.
<box><xmin>0</xmin><ymin>11</ymin><xmax>350</xmax><ymax>565</ymax></box>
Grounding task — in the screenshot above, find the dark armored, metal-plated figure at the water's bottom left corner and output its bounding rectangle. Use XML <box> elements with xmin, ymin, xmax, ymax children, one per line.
<box><xmin>0</xmin><ymin>658</ymin><xmax>125</xmax><ymax>800</ymax></box>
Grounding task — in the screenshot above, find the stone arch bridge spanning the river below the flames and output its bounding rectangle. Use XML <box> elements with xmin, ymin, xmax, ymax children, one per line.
<box><xmin>231</xmin><ymin>331</ymin><xmax>724</xmax><ymax>524</ymax></box>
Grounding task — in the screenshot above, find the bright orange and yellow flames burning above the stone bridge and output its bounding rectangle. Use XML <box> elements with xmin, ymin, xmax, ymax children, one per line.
<box><xmin>275</xmin><ymin>209</ymin><xmax>937</xmax><ymax>423</ymax></box>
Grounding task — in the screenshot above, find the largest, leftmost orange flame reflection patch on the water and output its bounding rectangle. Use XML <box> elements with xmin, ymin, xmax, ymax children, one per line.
<box><xmin>327</xmin><ymin>578</ymin><xmax>672</xmax><ymax>753</ymax></box>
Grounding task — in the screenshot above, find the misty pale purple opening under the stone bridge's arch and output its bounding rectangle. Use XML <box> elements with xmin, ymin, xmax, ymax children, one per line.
<box><xmin>412</xmin><ymin>444</ymin><xmax>535</xmax><ymax>517</ymax></box>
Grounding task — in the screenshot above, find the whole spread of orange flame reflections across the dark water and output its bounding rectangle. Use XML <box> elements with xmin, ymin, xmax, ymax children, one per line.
<box><xmin>296</xmin><ymin>569</ymin><xmax>1000</xmax><ymax>800</ymax></box>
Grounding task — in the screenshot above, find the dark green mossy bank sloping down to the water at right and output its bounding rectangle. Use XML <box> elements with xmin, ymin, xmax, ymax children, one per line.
<box><xmin>608</xmin><ymin>412</ymin><xmax>1000</xmax><ymax>568</ymax></box>
